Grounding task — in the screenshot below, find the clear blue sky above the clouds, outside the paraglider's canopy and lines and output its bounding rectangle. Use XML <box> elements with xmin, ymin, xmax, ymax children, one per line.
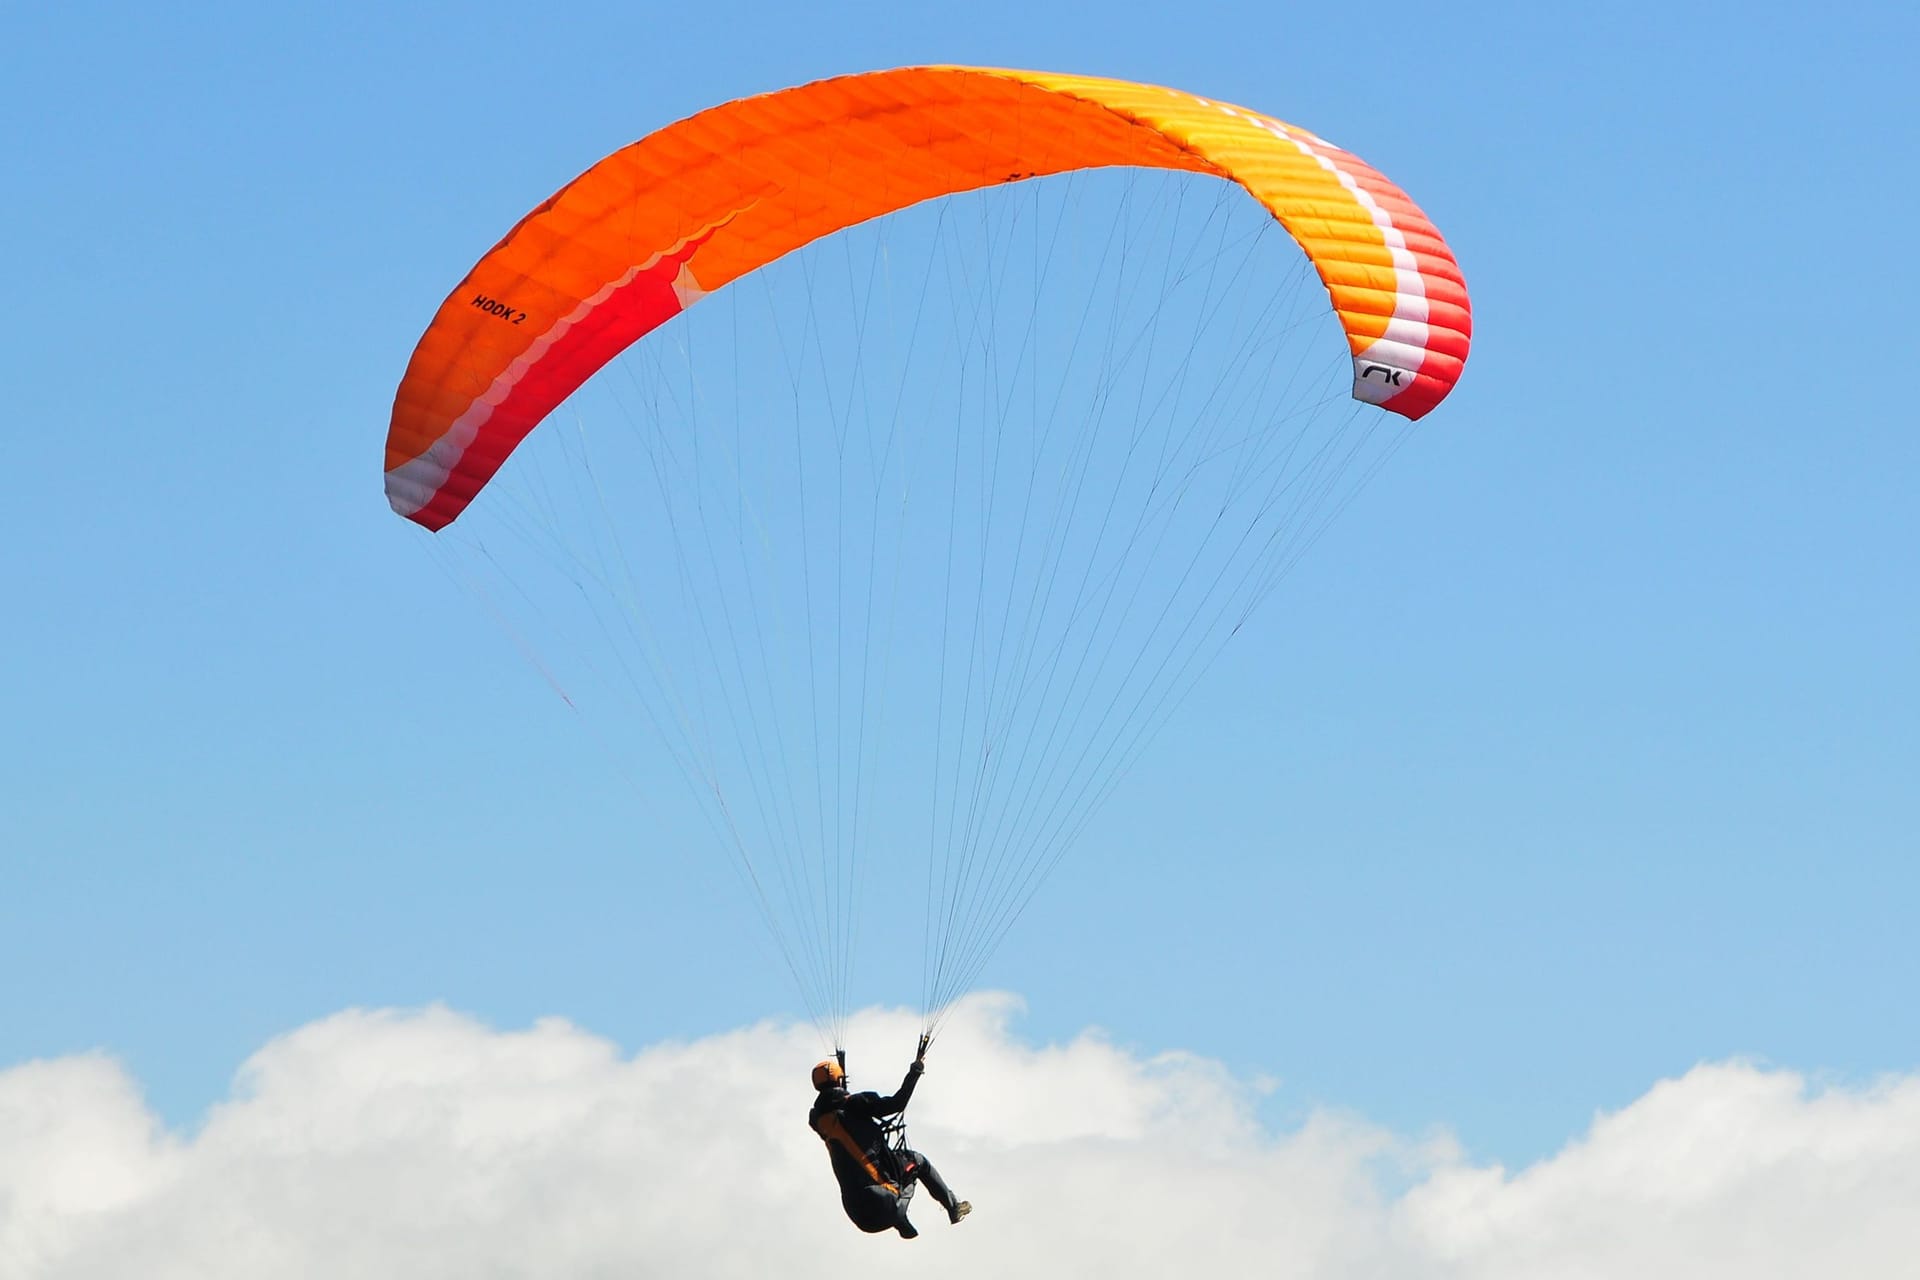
<box><xmin>0</xmin><ymin>4</ymin><xmax>1920</xmax><ymax>1182</ymax></box>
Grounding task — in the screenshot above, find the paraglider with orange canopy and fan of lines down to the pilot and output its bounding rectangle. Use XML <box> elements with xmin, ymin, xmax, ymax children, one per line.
<box><xmin>384</xmin><ymin>65</ymin><xmax>1471</xmax><ymax>1174</ymax></box>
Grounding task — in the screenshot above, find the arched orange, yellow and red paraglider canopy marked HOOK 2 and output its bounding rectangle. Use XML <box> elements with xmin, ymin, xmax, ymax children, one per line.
<box><xmin>386</xmin><ymin>67</ymin><xmax>1471</xmax><ymax>528</ymax></box>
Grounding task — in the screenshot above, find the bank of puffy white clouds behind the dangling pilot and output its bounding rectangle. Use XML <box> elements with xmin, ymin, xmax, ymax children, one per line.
<box><xmin>0</xmin><ymin>998</ymin><xmax>1920</xmax><ymax>1280</ymax></box>
